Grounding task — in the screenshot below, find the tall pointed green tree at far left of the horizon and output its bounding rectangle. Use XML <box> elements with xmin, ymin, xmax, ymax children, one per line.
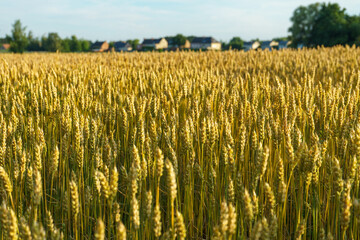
<box><xmin>6</xmin><ymin>20</ymin><xmax>28</xmax><ymax>53</ymax></box>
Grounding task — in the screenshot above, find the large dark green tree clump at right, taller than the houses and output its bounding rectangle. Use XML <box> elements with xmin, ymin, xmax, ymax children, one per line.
<box><xmin>289</xmin><ymin>3</ymin><xmax>360</xmax><ymax>47</ymax></box>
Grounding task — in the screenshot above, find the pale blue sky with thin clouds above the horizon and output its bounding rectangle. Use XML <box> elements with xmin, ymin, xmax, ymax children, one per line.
<box><xmin>0</xmin><ymin>0</ymin><xmax>360</xmax><ymax>41</ymax></box>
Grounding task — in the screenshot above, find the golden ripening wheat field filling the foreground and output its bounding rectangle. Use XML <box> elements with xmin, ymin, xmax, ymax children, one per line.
<box><xmin>0</xmin><ymin>47</ymin><xmax>360</xmax><ymax>240</ymax></box>
